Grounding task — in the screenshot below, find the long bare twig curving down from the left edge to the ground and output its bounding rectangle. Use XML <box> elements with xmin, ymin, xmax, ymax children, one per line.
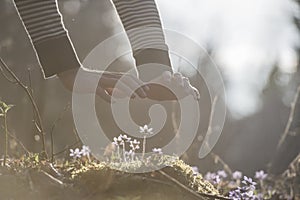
<box><xmin>0</xmin><ymin>57</ymin><xmax>47</xmax><ymax>157</ymax></box>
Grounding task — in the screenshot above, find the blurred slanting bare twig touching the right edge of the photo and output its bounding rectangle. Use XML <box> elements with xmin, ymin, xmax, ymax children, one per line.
<box><xmin>277</xmin><ymin>85</ymin><xmax>300</xmax><ymax>149</ymax></box>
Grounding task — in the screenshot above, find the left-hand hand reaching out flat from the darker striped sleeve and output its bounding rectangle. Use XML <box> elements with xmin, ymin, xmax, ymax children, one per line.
<box><xmin>58</xmin><ymin>68</ymin><xmax>149</xmax><ymax>102</ymax></box>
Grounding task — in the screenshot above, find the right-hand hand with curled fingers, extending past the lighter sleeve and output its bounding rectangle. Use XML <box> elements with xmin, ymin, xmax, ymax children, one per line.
<box><xmin>146</xmin><ymin>71</ymin><xmax>200</xmax><ymax>101</ymax></box>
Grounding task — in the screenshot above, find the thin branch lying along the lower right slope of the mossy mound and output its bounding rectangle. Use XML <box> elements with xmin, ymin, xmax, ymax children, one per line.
<box><xmin>158</xmin><ymin>170</ymin><xmax>230</xmax><ymax>200</ymax></box>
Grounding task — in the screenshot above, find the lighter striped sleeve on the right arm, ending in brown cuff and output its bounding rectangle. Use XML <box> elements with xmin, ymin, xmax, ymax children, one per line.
<box><xmin>112</xmin><ymin>0</ymin><xmax>171</xmax><ymax>78</ymax></box>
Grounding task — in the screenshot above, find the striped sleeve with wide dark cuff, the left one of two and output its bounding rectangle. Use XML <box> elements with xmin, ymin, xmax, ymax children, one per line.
<box><xmin>14</xmin><ymin>0</ymin><xmax>80</xmax><ymax>78</ymax></box>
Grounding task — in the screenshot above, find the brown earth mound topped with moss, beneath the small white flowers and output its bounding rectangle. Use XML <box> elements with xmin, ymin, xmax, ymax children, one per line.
<box><xmin>0</xmin><ymin>157</ymin><xmax>223</xmax><ymax>200</ymax></box>
